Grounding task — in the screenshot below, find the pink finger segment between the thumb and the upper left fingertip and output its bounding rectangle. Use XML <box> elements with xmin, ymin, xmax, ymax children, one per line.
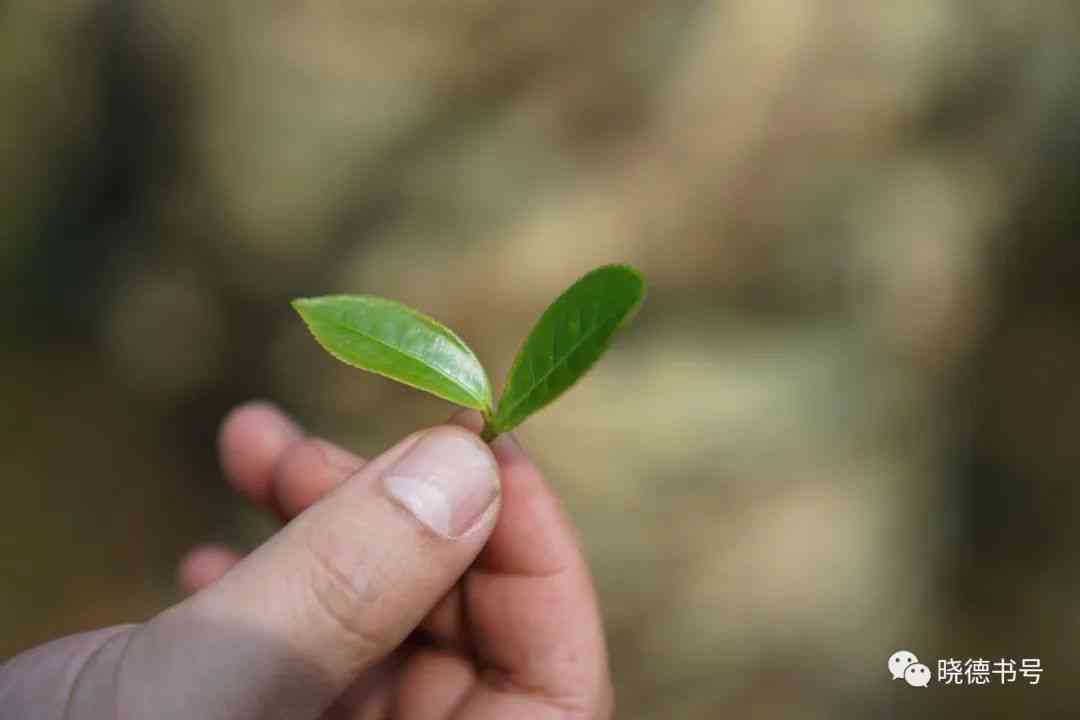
<box><xmin>270</xmin><ymin>437</ymin><xmax>364</xmax><ymax>521</ymax></box>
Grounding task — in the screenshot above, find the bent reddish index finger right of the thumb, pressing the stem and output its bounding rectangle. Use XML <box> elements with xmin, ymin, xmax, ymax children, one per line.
<box><xmin>447</xmin><ymin>436</ymin><xmax>613</xmax><ymax>719</ymax></box>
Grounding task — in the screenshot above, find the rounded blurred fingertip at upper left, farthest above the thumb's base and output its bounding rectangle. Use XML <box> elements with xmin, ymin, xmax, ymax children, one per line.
<box><xmin>217</xmin><ymin>402</ymin><xmax>303</xmax><ymax>505</ymax></box>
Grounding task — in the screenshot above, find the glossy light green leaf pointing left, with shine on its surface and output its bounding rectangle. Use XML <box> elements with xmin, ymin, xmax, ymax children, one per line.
<box><xmin>293</xmin><ymin>295</ymin><xmax>491</xmax><ymax>416</ymax></box>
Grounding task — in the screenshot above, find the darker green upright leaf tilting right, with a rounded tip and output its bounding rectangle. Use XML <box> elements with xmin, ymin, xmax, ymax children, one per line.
<box><xmin>492</xmin><ymin>266</ymin><xmax>645</xmax><ymax>433</ymax></box>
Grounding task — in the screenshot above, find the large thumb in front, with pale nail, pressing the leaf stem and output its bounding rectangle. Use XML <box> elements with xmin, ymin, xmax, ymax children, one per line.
<box><xmin>118</xmin><ymin>426</ymin><xmax>499</xmax><ymax>718</ymax></box>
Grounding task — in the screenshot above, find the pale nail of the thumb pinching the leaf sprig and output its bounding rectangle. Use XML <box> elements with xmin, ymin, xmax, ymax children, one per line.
<box><xmin>382</xmin><ymin>429</ymin><xmax>499</xmax><ymax>538</ymax></box>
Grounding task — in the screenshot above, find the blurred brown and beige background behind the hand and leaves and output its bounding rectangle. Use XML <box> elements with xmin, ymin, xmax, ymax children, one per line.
<box><xmin>0</xmin><ymin>0</ymin><xmax>1080</xmax><ymax>720</ymax></box>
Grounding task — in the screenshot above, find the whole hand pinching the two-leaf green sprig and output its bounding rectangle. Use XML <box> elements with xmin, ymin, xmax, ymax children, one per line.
<box><xmin>0</xmin><ymin>404</ymin><xmax>613</xmax><ymax>720</ymax></box>
